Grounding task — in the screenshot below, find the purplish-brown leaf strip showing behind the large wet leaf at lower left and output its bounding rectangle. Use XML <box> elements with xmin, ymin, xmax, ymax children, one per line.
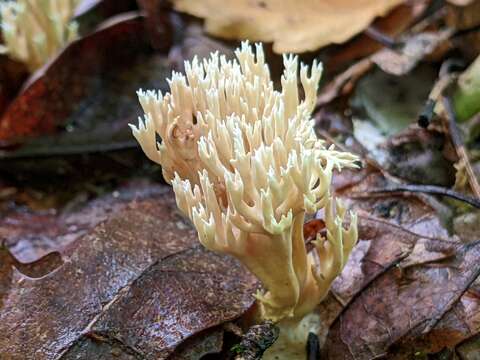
<box><xmin>0</xmin><ymin>182</ymin><xmax>167</xmax><ymax>262</ymax></box>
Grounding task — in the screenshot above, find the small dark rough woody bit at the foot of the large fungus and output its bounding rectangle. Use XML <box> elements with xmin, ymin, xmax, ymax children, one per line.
<box><xmin>232</xmin><ymin>320</ymin><xmax>280</xmax><ymax>360</ymax></box>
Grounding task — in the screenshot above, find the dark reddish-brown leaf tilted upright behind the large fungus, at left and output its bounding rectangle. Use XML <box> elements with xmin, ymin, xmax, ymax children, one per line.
<box><xmin>0</xmin><ymin>13</ymin><xmax>167</xmax><ymax>148</ymax></box>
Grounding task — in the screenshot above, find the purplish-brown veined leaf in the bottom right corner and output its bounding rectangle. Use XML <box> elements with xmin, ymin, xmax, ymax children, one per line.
<box><xmin>324</xmin><ymin>242</ymin><xmax>480</xmax><ymax>360</ymax></box>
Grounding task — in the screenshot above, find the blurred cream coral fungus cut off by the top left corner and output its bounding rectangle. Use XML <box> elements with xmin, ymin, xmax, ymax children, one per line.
<box><xmin>0</xmin><ymin>0</ymin><xmax>80</xmax><ymax>71</ymax></box>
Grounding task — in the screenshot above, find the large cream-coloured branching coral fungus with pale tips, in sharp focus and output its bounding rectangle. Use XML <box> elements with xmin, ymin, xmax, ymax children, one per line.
<box><xmin>132</xmin><ymin>43</ymin><xmax>357</xmax><ymax>321</ymax></box>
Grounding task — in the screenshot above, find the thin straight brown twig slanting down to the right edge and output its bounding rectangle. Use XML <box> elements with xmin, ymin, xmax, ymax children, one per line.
<box><xmin>441</xmin><ymin>96</ymin><xmax>480</xmax><ymax>199</ymax></box>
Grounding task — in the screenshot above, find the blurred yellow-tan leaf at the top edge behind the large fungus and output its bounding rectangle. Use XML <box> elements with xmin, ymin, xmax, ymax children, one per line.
<box><xmin>174</xmin><ymin>0</ymin><xmax>403</xmax><ymax>53</ymax></box>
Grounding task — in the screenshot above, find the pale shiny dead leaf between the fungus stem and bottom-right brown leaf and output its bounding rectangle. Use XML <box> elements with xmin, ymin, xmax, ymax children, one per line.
<box><xmin>318</xmin><ymin>210</ymin><xmax>458</xmax><ymax>343</ymax></box>
